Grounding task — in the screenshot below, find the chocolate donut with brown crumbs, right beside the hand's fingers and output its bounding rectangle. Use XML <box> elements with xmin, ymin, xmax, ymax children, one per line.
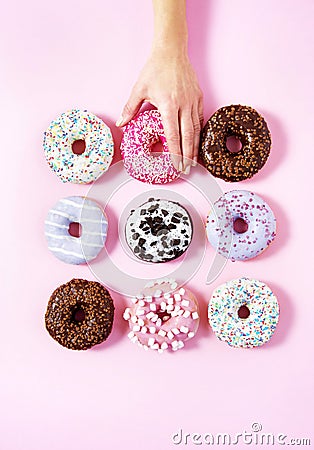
<box><xmin>200</xmin><ymin>105</ymin><xmax>271</xmax><ymax>181</ymax></box>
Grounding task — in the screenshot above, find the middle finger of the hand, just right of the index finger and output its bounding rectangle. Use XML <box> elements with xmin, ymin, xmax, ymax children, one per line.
<box><xmin>180</xmin><ymin>108</ymin><xmax>194</xmax><ymax>175</ymax></box>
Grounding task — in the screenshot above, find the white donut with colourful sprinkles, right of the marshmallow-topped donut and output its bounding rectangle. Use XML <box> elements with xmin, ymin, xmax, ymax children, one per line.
<box><xmin>208</xmin><ymin>278</ymin><xmax>279</xmax><ymax>348</ymax></box>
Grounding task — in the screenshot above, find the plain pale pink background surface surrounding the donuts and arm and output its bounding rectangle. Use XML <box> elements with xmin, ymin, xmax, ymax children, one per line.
<box><xmin>0</xmin><ymin>0</ymin><xmax>314</xmax><ymax>450</ymax></box>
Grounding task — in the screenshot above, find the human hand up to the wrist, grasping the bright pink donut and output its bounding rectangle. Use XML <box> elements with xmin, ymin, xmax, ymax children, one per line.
<box><xmin>117</xmin><ymin>49</ymin><xmax>203</xmax><ymax>174</ymax></box>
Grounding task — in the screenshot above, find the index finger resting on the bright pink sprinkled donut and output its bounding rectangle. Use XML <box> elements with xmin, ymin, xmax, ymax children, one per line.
<box><xmin>159</xmin><ymin>108</ymin><xmax>182</xmax><ymax>172</ymax></box>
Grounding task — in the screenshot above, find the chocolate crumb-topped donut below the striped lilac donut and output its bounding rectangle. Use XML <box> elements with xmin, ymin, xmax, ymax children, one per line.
<box><xmin>45</xmin><ymin>279</ymin><xmax>114</xmax><ymax>350</ymax></box>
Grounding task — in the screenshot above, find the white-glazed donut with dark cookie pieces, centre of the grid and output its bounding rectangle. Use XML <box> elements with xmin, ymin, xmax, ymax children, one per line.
<box><xmin>125</xmin><ymin>198</ymin><xmax>193</xmax><ymax>263</ymax></box>
